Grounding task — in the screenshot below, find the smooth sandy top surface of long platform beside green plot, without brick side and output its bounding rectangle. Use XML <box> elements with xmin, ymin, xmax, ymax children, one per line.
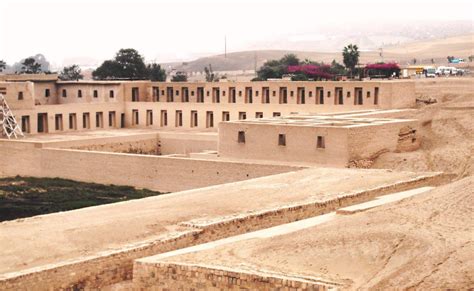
<box><xmin>0</xmin><ymin>169</ymin><xmax>426</xmax><ymax>274</ymax></box>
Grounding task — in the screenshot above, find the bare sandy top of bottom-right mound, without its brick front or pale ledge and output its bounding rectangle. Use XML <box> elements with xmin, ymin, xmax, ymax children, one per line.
<box><xmin>165</xmin><ymin>177</ymin><xmax>474</xmax><ymax>290</ymax></box>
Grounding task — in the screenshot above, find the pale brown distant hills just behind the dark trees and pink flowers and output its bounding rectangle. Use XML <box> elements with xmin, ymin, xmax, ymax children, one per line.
<box><xmin>163</xmin><ymin>34</ymin><xmax>474</xmax><ymax>72</ymax></box>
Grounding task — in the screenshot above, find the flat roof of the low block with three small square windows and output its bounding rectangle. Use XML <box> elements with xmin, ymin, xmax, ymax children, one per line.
<box><xmin>228</xmin><ymin>114</ymin><xmax>414</xmax><ymax>128</ymax></box>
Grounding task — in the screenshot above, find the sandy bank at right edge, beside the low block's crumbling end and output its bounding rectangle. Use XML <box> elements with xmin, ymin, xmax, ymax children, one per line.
<box><xmin>373</xmin><ymin>78</ymin><xmax>474</xmax><ymax>178</ymax></box>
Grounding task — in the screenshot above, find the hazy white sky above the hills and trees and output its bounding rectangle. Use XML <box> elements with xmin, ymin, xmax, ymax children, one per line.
<box><xmin>0</xmin><ymin>0</ymin><xmax>474</xmax><ymax>65</ymax></box>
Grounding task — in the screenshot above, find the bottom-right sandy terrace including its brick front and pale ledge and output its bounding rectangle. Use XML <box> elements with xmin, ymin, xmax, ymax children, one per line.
<box><xmin>133</xmin><ymin>177</ymin><xmax>474</xmax><ymax>290</ymax></box>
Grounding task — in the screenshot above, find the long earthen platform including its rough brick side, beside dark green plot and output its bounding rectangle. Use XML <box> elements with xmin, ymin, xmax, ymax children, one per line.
<box><xmin>0</xmin><ymin>168</ymin><xmax>442</xmax><ymax>290</ymax></box>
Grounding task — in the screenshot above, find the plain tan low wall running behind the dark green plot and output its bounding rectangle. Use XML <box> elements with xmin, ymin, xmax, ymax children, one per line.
<box><xmin>0</xmin><ymin>141</ymin><xmax>302</xmax><ymax>192</ymax></box>
